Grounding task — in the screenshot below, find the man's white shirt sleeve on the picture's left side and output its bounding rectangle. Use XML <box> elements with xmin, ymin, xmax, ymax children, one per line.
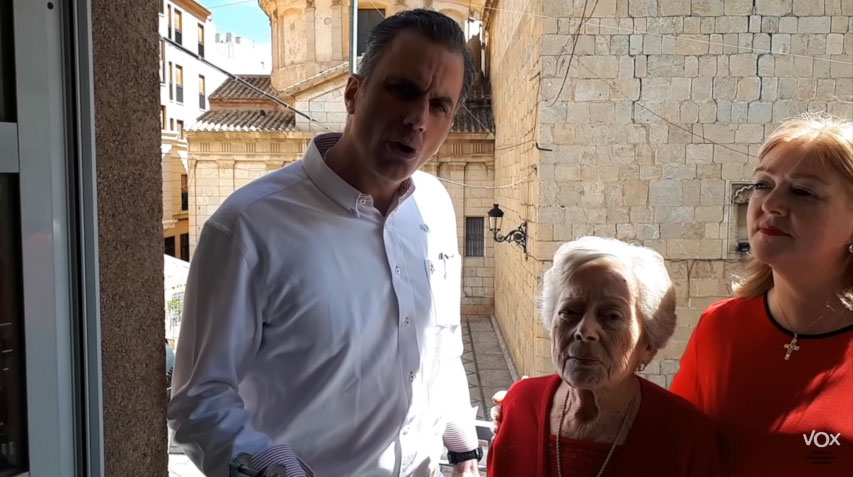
<box><xmin>167</xmin><ymin>222</ymin><xmax>306</xmax><ymax>477</ymax></box>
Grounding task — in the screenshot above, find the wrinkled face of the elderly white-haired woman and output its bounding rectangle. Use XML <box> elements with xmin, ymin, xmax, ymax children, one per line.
<box><xmin>551</xmin><ymin>260</ymin><xmax>642</xmax><ymax>389</ymax></box>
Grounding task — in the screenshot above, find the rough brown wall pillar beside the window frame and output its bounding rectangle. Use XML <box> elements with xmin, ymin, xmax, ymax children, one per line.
<box><xmin>92</xmin><ymin>0</ymin><xmax>168</xmax><ymax>470</ymax></box>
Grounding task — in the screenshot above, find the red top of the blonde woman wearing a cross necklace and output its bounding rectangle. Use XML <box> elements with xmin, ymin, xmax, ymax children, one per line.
<box><xmin>671</xmin><ymin>297</ymin><xmax>853</xmax><ymax>477</ymax></box>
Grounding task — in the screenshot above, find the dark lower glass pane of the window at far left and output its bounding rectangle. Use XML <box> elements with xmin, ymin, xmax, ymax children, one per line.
<box><xmin>0</xmin><ymin>174</ymin><xmax>28</xmax><ymax>476</ymax></box>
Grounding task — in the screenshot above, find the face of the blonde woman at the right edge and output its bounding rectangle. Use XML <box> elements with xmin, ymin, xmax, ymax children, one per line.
<box><xmin>747</xmin><ymin>144</ymin><xmax>853</xmax><ymax>269</ymax></box>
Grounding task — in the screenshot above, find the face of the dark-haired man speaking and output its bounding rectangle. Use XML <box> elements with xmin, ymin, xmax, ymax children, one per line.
<box><xmin>345</xmin><ymin>32</ymin><xmax>465</xmax><ymax>186</ymax></box>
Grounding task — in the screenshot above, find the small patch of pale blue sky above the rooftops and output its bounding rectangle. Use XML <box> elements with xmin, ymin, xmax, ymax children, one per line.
<box><xmin>197</xmin><ymin>0</ymin><xmax>270</xmax><ymax>43</ymax></box>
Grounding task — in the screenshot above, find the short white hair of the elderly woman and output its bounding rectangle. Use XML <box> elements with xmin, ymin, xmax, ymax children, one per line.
<box><xmin>539</xmin><ymin>237</ymin><xmax>676</xmax><ymax>350</ymax></box>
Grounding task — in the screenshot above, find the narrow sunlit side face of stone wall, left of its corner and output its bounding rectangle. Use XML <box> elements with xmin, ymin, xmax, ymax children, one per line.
<box><xmin>486</xmin><ymin>0</ymin><xmax>550</xmax><ymax>375</ymax></box>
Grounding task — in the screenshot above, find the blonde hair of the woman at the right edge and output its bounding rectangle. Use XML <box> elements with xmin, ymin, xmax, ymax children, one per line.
<box><xmin>734</xmin><ymin>114</ymin><xmax>853</xmax><ymax>310</ymax></box>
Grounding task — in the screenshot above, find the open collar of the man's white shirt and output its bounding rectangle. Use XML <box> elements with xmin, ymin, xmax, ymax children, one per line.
<box><xmin>303</xmin><ymin>132</ymin><xmax>415</xmax><ymax>216</ymax></box>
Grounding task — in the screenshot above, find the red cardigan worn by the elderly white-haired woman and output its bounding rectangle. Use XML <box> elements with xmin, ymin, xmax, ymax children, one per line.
<box><xmin>488</xmin><ymin>374</ymin><xmax>719</xmax><ymax>477</ymax></box>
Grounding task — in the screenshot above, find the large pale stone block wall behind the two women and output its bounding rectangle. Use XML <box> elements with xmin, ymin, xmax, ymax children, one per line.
<box><xmin>490</xmin><ymin>0</ymin><xmax>853</xmax><ymax>384</ymax></box>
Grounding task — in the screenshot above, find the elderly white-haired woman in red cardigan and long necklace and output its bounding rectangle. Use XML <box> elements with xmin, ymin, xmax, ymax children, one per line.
<box><xmin>488</xmin><ymin>237</ymin><xmax>719</xmax><ymax>477</ymax></box>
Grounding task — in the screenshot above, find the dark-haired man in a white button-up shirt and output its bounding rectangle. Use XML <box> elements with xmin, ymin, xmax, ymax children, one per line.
<box><xmin>168</xmin><ymin>10</ymin><xmax>480</xmax><ymax>477</ymax></box>
